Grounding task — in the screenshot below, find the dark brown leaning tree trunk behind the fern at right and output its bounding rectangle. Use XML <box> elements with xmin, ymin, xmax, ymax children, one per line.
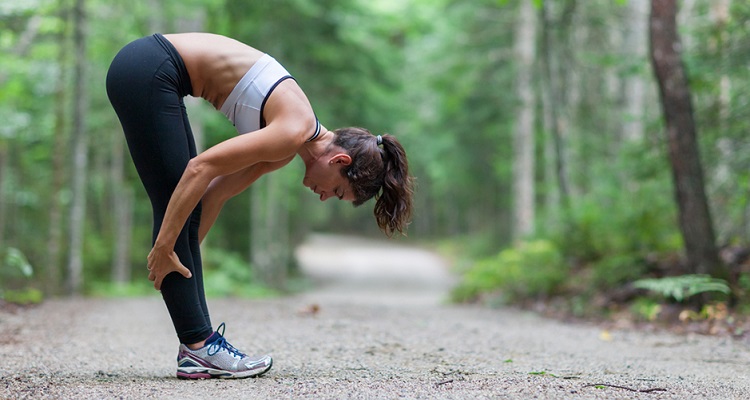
<box><xmin>650</xmin><ymin>0</ymin><xmax>724</xmax><ymax>276</ymax></box>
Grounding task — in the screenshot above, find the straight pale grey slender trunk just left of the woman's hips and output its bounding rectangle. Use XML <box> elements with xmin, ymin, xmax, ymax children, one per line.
<box><xmin>68</xmin><ymin>0</ymin><xmax>88</xmax><ymax>295</ymax></box>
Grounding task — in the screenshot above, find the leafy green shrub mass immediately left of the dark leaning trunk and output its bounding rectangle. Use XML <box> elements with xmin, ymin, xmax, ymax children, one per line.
<box><xmin>547</xmin><ymin>138</ymin><xmax>682</xmax><ymax>290</ymax></box>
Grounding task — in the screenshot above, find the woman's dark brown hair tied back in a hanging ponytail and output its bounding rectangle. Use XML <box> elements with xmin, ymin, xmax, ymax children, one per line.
<box><xmin>333</xmin><ymin>127</ymin><xmax>414</xmax><ymax>237</ymax></box>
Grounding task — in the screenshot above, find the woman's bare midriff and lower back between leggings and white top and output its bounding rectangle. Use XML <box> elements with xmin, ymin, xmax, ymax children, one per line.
<box><xmin>164</xmin><ymin>33</ymin><xmax>263</xmax><ymax>110</ymax></box>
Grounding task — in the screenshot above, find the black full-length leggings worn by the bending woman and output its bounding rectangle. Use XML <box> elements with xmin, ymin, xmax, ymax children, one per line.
<box><xmin>107</xmin><ymin>34</ymin><xmax>213</xmax><ymax>343</ymax></box>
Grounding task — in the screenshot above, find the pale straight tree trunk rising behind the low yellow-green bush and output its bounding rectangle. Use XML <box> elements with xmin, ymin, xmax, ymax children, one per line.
<box><xmin>513</xmin><ymin>1</ymin><xmax>536</xmax><ymax>239</ymax></box>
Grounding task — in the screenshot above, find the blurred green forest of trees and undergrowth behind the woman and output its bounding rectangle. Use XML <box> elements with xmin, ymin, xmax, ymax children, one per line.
<box><xmin>0</xmin><ymin>0</ymin><xmax>750</xmax><ymax>319</ymax></box>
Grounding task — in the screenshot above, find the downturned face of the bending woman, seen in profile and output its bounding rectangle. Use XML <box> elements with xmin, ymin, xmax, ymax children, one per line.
<box><xmin>302</xmin><ymin>153</ymin><xmax>355</xmax><ymax>201</ymax></box>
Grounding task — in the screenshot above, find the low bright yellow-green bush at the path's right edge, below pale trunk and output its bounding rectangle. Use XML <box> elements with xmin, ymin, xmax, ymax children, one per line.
<box><xmin>452</xmin><ymin>240</ymin><xmax>568</xmax><ymax>301</ymax></box>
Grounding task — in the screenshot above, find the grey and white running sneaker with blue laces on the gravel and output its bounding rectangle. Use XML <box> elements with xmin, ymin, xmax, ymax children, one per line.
<box><xmin>177</xmin><ymin>322</ymin><xmax>273</xmax><ymax>379</ymax></box>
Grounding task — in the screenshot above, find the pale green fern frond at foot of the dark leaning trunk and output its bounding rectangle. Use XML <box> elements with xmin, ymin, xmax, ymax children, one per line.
<box><xmin>633</xmin><ymin>274</ymin><xmax>731</xmax><ymax>302</ymax></box>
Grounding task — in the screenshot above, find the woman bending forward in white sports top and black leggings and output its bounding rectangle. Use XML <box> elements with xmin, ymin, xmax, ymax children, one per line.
<box><xmin>107</xmin><ymin>33</ymin><xmax>412</xmax><ymax>379</ymax></box>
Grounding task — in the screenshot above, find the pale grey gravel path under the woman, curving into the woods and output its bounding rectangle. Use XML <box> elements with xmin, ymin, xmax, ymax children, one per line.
<box><xmin>0</xmin><ymin>237</ymin><xmax>750</xmax><ymax>399</ymax></box>
